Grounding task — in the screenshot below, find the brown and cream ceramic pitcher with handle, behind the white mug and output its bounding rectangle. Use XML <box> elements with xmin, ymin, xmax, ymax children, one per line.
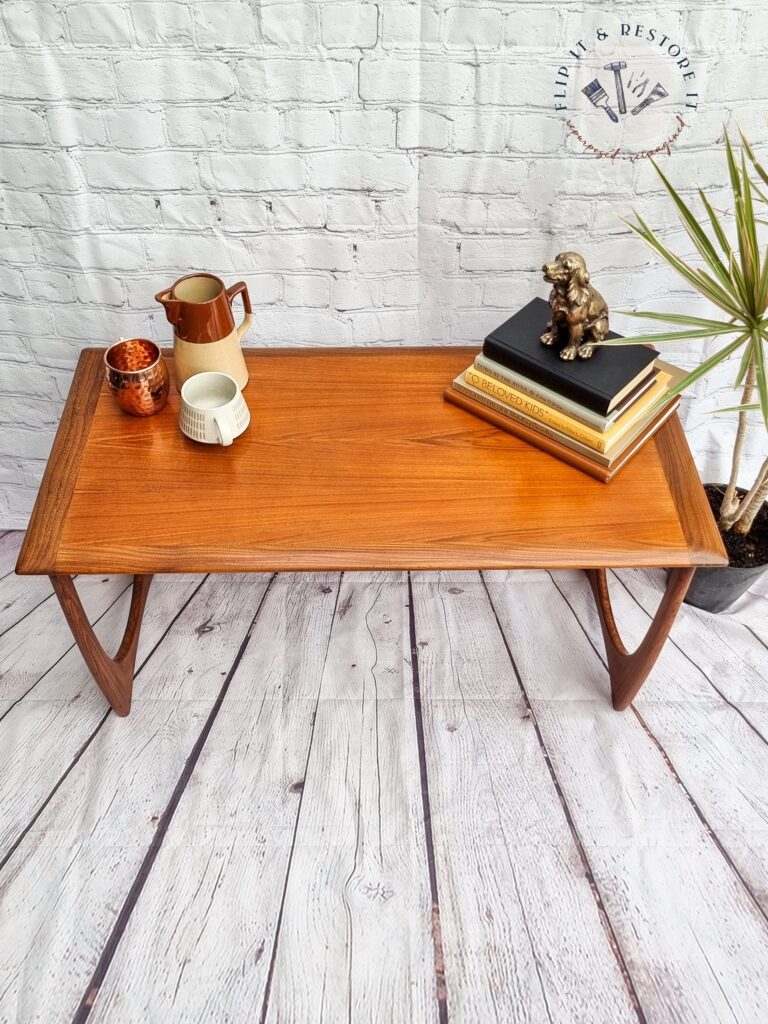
<box><xmin>155</xmin><ymin>273</ymin><xmax>251</xmax><ymax>388</ymax></box>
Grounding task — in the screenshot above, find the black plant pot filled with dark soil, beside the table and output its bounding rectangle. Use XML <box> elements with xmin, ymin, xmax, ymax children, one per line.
<box><xmin>685</xmin><ymin>483</ymin><xmax>768</xmax><ymax>611</ymax></box>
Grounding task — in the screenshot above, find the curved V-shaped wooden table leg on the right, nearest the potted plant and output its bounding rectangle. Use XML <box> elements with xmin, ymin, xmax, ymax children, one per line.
<box><xmin>587</xmin><ymin>568</ymin><xmax>693</xmax><ymax>711</ymax></box>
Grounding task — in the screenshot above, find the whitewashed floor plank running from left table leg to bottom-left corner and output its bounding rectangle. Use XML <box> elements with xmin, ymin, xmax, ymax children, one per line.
<box><xmin>0</xmin><ymin>577</ymin><xmax>268</xmax><ymax>1021</ymax></box>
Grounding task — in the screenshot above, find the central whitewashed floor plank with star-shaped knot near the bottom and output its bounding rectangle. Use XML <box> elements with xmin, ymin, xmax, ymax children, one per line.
<box><xmin>267</xmin><ymin>573</ymin><xmax>438</xmax><ymax>1024</ymax></box>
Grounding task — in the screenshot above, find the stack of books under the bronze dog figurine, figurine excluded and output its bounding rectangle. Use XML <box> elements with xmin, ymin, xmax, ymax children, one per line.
<box><xmin>445</xmin><ymin>299</ymin><xmax>683</xmax><ymax>482</ymax></box>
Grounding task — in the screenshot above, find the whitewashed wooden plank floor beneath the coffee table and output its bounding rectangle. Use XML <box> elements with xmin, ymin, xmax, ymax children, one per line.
<box><xmin>0</xmin><ymin>534</ymin><xmax>768</xmax><ymax>1024</ymax></box>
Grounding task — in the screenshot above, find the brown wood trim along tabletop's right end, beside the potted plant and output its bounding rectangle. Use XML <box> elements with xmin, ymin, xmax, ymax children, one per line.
<box><xmin>656</xmin><ymin>413</ymin><xmax>728</xmax><ymax>565</ymax></box>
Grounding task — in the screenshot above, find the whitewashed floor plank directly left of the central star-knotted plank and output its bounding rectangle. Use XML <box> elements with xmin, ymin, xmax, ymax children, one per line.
<box><xmin>82</xmin><ymin>574</ymin><xmax>339</xmax><ymax>1024</ymax></box>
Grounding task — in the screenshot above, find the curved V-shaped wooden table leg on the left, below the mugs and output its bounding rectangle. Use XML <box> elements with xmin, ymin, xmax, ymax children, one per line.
<box><xmin>50</xmin><ymin>575</ymin><xmax>152</xmax><ymax>715</ymax></box>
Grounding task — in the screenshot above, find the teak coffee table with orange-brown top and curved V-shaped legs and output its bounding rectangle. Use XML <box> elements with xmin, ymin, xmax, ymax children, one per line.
<box><xmin>16</xmin><ymin>348</ymin><xmax>727</xmax><ymax>715</ymax></box>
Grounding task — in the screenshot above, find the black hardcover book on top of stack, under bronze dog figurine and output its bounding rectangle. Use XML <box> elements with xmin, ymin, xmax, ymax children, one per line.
<box><xmin>482</xmin><ymin>299</ymin><xmax>658</xmax><ymax>416</ymax></box>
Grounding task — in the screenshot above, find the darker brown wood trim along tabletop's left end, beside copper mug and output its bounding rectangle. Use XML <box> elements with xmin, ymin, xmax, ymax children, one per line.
<box><xmin>16</xmin><ymin>348</ymin><xmax>103</xmax><ymax>575</ymax></box>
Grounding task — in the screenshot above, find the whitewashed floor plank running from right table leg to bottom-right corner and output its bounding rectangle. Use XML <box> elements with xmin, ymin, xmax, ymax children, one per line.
<box><xmin>488</xmin><ymin>572</ymin><xmax>768</xmax><ymax>1024</ymax></box>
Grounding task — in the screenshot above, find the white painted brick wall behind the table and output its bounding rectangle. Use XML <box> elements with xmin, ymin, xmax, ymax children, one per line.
<box><xmin>0</xmin><ymin>0</ymin><xmax>768</xmax><ymax>527</ymax></box>
